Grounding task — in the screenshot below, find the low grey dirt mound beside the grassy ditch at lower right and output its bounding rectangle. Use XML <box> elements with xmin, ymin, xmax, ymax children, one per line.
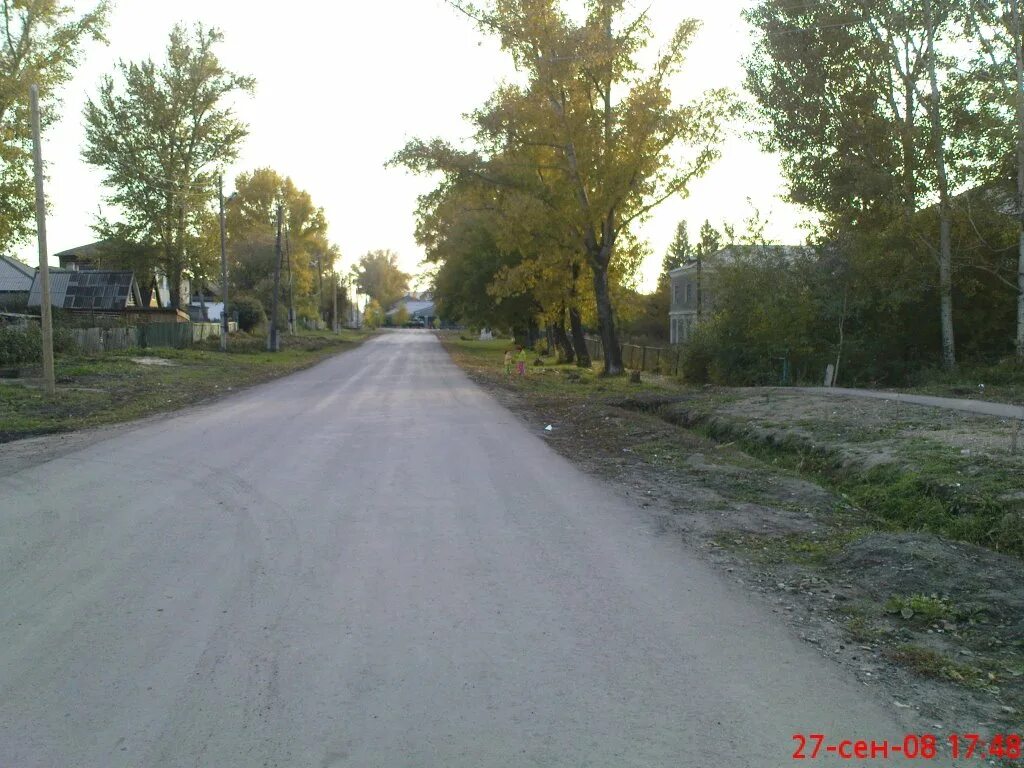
<box><xmin>835</xmin><ymin>534</ymin><xmax>1024</xmax><ymax>638</ymax></box>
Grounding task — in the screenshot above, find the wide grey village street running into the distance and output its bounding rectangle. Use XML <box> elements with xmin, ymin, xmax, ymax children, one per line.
<box><xmin>0</xmin><ymin>332</ymin><xmax>921</xmax><ymax>768</ymax></box>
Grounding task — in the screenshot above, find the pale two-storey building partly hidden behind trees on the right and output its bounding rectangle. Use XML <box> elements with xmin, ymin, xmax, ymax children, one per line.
<box><xmin>669</xmin><ymin>245</ymin><xmax>813</xmax><ymax>344</ymax></box>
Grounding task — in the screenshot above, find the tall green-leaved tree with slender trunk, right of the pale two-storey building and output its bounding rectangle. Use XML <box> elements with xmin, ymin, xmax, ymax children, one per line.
<box><xmin>745</xmin><ymin>0</ymin><xmax>966</xmax><ymax>367</ymax></box>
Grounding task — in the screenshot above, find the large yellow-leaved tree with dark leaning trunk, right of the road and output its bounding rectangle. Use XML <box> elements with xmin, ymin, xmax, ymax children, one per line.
<box><xmin>396</xmin><ymin>0</ymin><xmax>730</xmax><ymax>375</ymax></box>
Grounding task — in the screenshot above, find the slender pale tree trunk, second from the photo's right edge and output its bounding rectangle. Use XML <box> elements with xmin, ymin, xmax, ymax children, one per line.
<box><xmin>925</xmin><ymin>0</ymin><xmax>956</xmax><ymax>371</ymax></box>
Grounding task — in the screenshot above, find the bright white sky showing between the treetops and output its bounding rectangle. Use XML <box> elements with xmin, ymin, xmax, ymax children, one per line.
<box><xmin>19</xmin><ymin>0</ymin><xmax>805</xmax><ymax>288</ymax></box>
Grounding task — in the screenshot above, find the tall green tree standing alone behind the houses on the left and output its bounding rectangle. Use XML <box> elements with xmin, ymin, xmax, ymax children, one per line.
<box><xmin>82</xmin><ymin>25</ymin><xmax>255</xmax><ymax>307</ymax></box>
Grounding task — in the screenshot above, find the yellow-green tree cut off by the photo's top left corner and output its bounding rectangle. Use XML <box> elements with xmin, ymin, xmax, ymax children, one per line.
<box><xmin>0</xmin><ymin>0</ymin><xmax>109</xmax><ymax>246</ymax></box>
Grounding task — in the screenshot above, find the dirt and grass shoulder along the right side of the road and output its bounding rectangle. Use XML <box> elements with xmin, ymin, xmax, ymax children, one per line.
<box><xmin>446</xmin><ymin>339</ymin><xmax>1024</xmax><ymax>761</ymax></box>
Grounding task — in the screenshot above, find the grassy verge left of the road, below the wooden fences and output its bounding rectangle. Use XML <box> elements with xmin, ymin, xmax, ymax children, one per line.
<box><xmin>0</xmin><ymin>331</ymin><xmax>368</xmax><ymax>442</ymax></box>
